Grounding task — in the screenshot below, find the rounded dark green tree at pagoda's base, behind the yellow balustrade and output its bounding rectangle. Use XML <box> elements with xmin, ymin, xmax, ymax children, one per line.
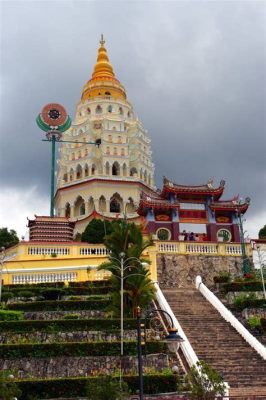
<box><xmin>81</xmin><ymin>218</ymin><xmax>112</xmax><ymax>244</ymax></box>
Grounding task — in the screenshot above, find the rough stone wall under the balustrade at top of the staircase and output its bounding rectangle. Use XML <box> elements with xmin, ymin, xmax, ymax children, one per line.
<box><xmin>157</xmin><ymin>254</ymin><xmax>250</xmax><ymax>288</ymax></box>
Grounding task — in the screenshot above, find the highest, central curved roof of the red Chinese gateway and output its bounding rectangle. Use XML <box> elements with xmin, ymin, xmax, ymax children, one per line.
<box><xmin>162</xmin><ymin>177</ymin><xmax>225</xmax><ymax>200</ymax></box>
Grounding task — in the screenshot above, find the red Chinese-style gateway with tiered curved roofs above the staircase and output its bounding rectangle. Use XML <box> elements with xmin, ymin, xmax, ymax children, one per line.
<box><xmin>138</xmin><ymin>178</ymin><xmax>249</xmax><ymax>242</ymax></box>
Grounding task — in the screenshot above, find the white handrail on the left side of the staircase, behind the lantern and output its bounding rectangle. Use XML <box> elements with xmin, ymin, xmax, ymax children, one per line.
<box><xmin>154</xmin><ymin>282</ymin><xmax>199</xmax><ymax>367</ymax></box>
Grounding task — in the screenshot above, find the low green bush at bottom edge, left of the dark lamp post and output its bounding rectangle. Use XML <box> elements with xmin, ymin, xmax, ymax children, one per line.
<box><xmin>87</xmin><ymin>376</ymin><xmax>130</xmax><ymax>400</ymax></box>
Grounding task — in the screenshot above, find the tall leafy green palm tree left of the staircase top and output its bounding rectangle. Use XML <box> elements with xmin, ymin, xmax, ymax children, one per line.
<box><xmin>98</xmin><ymin>220</ymin><xmax>155</xmax><ymax>314</ymax></box>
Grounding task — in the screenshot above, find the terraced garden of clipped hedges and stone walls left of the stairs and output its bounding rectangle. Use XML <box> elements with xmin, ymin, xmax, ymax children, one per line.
<box><xmin>0</xmin><ymin>281</ymin><xmax>181</xmax><ymax>400</ymax></box>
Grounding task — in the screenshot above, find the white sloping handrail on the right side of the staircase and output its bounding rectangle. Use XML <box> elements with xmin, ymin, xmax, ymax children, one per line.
<box><xmin>196</xmin><ymin>276</ymin><xmax>266</xmax><ymax>360</ymax></box>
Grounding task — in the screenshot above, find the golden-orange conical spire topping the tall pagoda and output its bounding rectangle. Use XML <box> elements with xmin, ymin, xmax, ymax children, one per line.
<box><xmin>81</xmin><ymin>35</ymin><xmax>127</xmax><ymax>102</ymax></box>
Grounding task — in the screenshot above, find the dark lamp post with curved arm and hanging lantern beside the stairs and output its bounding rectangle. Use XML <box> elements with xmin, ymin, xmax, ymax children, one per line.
<box><xmin>137</xmin><ymin>307</ymin><xmax>184</xmax><ymax>400</ymax></box>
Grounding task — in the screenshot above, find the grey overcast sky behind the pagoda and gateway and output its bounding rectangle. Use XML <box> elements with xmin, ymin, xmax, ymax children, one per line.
<box><xmin>0</xmin><ymin>0</ymin><xmax>266</xmax><ymax>237</ymax></box>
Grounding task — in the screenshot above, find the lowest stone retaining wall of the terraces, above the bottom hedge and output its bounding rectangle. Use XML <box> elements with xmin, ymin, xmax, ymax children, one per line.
<box><xmin>0</xmin><ymin>354</ymin><xmax>169</xmax><ymax>379</ymax></box>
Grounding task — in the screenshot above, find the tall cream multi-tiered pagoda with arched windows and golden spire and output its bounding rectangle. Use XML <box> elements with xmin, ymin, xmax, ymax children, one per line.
<box><xmin>55</xmin><ymin>37</ymin><xmax>155</xmax><ymax>232</ymax></box>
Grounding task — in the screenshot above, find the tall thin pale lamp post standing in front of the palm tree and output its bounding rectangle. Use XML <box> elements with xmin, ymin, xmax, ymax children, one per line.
<box><xmin>106</xmin><ymin>252</ymin><xmax>148</xmax><ymax>386</ymax></box>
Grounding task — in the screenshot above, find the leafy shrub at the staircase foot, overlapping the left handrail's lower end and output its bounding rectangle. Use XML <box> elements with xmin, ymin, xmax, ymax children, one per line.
<box><xmin>186</xmin><ymin>361</ymin><xmax>226</xmax><ymax>400</ymax></box>
